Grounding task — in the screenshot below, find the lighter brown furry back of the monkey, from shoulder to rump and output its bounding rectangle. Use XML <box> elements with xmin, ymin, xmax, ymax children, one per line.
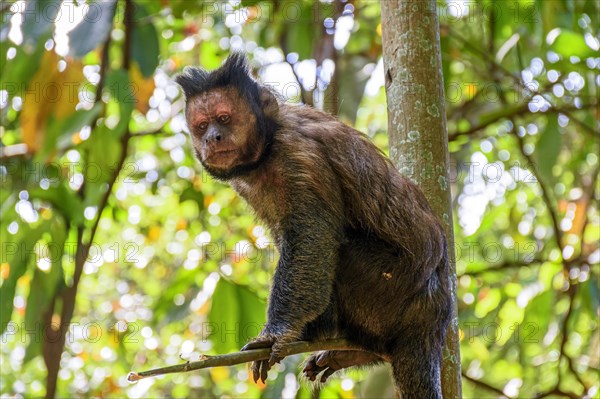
<box><xmin>277</xmin><ymin>105</ymin><xmax>445</xmax><ymax>263</ymax></box>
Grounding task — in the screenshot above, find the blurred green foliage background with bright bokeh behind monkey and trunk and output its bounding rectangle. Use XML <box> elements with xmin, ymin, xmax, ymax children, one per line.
<box><xmin>0</xmin><ymin>0</ymin><xmax>600</xmax><ymax>398</ymax></box>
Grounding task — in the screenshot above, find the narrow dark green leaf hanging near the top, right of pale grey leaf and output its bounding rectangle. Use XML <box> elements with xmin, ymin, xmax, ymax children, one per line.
<box><xmin>131</xmin><ymin>2</ymin><xmax>160</xmax><ymax>78</ymax></box>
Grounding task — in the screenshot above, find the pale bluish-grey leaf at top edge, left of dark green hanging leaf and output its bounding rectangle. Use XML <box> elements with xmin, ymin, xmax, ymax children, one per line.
<box><xmin>69</xmin><ymin>0</ymin><xmax>117</xmax><ymax>58</ymax></box>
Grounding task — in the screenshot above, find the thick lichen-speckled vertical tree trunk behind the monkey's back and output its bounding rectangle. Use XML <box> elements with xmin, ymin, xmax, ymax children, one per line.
<box><xmin>381</xmin><ymin>0</ymin><xmax>462</xmax><ymax>399</ymax></box>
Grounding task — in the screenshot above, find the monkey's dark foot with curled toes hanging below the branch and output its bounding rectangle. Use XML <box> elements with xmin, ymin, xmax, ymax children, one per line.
<box><xmin>302</xmin><ymin>351</ymin><xmax>381</xmax><ymax>383</ymax></box>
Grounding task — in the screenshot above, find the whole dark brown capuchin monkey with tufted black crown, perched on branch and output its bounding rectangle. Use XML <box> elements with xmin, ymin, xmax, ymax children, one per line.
<box><xmin>177</xmin><ymin>53</ymin><xmax>451</xmax><ymax>399</ymax></box>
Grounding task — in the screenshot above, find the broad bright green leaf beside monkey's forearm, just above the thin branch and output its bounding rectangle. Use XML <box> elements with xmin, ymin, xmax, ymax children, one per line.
<box><xmin>208</xmin><ymin>278</ymin><xmax>266</xmax><ymax>353</ymax></box>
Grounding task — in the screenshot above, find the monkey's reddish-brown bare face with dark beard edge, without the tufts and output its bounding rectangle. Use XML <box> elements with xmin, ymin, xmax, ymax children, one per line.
<box><xmin>186</xmin><ymin>87</ymin><xmax>262</xmax><ymax>177</ymax></box>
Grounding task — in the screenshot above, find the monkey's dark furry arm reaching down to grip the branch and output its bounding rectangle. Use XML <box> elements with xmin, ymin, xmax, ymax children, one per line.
<box><xmin>243</xmin><ymin>193</ymin><xmax>342</xmax><ymax>382</ymax></box>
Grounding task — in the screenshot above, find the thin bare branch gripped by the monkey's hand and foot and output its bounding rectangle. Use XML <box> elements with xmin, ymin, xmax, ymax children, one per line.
<box><xmin>127</xmin><ymin>338</ymin><xmax>361</xmax><ymax>382</ymax></box>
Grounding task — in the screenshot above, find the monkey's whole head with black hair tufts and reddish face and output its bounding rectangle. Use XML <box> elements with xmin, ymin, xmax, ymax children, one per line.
<box><xmin>176</xmin><ymin>53</ymin><xmax>279</xmax><ymax>179</ymax></box>
